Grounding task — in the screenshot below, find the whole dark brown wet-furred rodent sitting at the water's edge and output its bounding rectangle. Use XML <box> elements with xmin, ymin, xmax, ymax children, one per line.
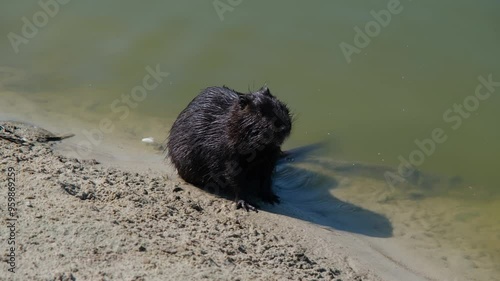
<box><xmin>167</xmin><ymin>87</ymin><xmax>292</xmax><ymax>206</ymax></box>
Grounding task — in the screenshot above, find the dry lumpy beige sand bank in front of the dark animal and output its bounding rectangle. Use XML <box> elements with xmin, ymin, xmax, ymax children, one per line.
<box><xmin>0</xmin><ymin>115</ymin><xmax>446</xmax><ymax>281</ymax></box>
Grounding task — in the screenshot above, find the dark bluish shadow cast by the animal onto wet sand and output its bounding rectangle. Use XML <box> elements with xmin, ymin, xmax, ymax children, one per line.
<box><xmin>264</xmin><ymin>145</ymin><xmax>393</xmax><ymax>238</ymax></box>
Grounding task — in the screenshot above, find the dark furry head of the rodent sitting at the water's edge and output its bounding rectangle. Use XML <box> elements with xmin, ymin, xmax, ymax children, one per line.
<box><xmin>238</xmin><ymin>87</ymin><xmax>292</xmax><ymax>146</ymax></box>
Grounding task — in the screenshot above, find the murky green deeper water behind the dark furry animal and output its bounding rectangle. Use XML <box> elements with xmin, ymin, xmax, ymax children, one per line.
<box><xmin>0</xmin><ymin>0</ymin><xmax>500</xmax><ymax>276</ymax></box>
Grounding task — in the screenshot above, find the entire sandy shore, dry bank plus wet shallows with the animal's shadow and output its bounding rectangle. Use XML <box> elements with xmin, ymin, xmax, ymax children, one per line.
<box><xmin>0</xmin><ymin>92</ymin><xmax>497</xmax><ymax>281</ymax></box>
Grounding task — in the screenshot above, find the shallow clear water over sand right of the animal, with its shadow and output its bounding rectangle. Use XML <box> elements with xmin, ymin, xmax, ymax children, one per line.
<box><xmin>276</xmin><ymin>149</ymin><xmax>500</xmax><ymax>280</ymax></box>
